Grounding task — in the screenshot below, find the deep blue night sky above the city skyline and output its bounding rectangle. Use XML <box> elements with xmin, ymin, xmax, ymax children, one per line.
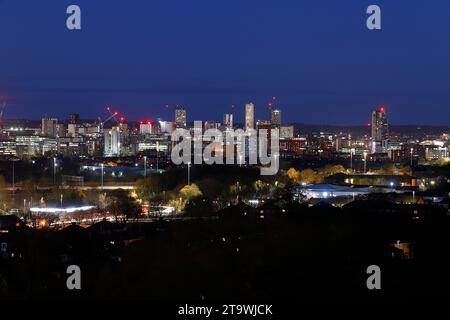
<box><xmin>0</xmin><ymin>0</ymin><xmax>450</xmax><ymax>124</ymax></box>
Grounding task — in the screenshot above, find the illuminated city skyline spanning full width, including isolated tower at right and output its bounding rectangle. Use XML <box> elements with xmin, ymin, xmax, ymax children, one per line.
<box><xmin>0</xmin><ymin>103</ymin><xmax>450</xmax><ymax>162</ymax></box>
